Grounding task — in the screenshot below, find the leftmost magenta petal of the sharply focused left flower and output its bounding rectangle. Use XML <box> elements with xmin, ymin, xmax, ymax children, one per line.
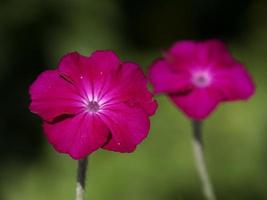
<box><xmin>29</xmin><ymin>70</ymin><xmax>83</xmax><ymax>121</ymax></box>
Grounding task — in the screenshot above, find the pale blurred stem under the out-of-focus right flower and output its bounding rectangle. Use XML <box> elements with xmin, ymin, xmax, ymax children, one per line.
<box><xmin>192</xmin><ymin>120</ymin><xmax>216</xmax><ymax>200</ymax></box>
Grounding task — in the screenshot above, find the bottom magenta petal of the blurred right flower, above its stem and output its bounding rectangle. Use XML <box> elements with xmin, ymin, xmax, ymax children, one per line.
<box><xmin>170</xmin><ymin>88</ymin><xmax>221</xmax><ymax>120</ymax></box>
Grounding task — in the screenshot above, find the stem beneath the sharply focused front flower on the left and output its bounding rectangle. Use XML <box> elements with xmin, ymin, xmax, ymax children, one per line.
<box><xmin>75</xmin><ymin>157</ymin><xmax>88</xmax><ymax>200</ymax></box>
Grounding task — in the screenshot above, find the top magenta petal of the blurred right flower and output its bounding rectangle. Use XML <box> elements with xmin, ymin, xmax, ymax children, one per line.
<box><xmin>164</xmin><ymin>39</ymin><xmax>236</xmax><ymax>70</ymax></box>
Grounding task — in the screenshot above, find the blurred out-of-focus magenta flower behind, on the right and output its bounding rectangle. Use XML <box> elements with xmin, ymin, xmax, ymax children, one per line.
<box><xmin>149</xmin><ymin>40</ymin><xmax>255</xmax><ymax>120</ymax></box>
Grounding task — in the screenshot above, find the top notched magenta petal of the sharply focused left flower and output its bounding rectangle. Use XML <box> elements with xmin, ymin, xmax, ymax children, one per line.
<box><xmin>59</xmin><ymin>50</ymin><xmax>120</xmax><ymax>100</ymax></box>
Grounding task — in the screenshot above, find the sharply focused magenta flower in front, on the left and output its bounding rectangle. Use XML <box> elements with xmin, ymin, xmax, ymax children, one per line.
<box><xmin>30</xmin><ymin>51</ymin><xmax>157</xmax><ymax>159</ymax></box>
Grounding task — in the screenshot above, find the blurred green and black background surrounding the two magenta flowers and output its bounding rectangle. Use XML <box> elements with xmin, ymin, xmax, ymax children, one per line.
<box><xmin>0</xmin><ymin>0</ymin><xmax>267</xmax><ymax>200</ymax></box>
